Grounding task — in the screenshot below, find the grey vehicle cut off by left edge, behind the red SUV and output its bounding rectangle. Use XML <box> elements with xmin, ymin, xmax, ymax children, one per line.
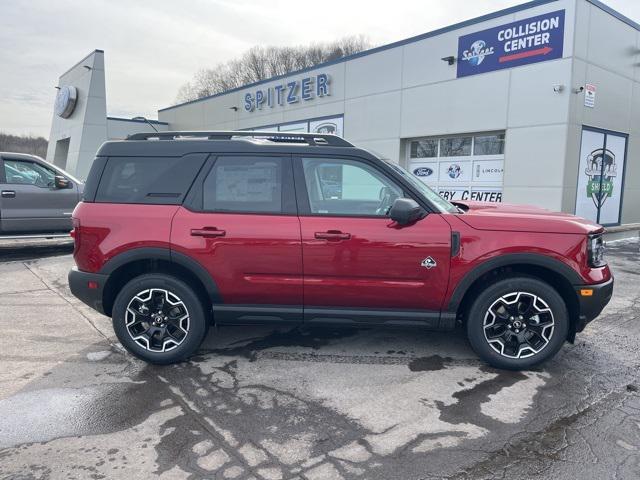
<box><xmin>0</xmin><ymin>158</ymin><xmax>78</xmax><ymax>233</ymax></box>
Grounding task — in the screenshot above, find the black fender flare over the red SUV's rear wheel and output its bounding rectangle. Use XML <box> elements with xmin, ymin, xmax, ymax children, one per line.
<box><xmin>98</xmin><ymin>247</ymin><xmax>222</xmax><ymax>303</ymax></box>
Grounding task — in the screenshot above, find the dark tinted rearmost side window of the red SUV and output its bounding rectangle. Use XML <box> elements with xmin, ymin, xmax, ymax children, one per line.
<box><xmin>95</xmin><ymin>155</ymin><xmax>205</xmax><ymax>205</ymax></box>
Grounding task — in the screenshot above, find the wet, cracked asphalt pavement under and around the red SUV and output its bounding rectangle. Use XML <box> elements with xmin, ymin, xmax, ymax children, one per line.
<box><xmin>0</xmin><ymin>242</ymin><xmax>640</xmax><ymax>480</ymax></box>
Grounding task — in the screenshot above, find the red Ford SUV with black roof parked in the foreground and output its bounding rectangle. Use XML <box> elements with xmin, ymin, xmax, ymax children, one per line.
<box><xmin>69</xmin><ymin>132</ymin><xmax>613</xmax><ymax>369</ymax></box>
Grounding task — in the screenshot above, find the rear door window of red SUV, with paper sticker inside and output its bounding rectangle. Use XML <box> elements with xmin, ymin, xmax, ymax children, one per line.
<box><xmin>202</xmin><ymin>157</ymin><xmax>283</xmax><ymax>213</ymax></box>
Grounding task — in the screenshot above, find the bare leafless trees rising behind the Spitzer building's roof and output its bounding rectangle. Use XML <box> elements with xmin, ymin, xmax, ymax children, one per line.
<box><xmin>176</xmin><ymin>35</ymin><xmax>371</xmax><ymax>102</ymax></box>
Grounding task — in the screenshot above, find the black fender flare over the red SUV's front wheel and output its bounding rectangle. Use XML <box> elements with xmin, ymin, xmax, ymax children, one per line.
<box><xmin>448</xmin><ymin>253</ymin><xmax>584</xmax><ymax>312</ymax></box>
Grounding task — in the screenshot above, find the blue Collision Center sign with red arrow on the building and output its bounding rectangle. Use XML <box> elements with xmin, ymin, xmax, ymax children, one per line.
<box><xmin>458</xmin><ymin>10</ymin><xmax>564</xmax><ymax>77</ymax></box>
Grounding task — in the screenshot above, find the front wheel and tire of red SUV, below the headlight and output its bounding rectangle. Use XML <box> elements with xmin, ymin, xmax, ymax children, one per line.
<box><xmin>467</xmin><ymin>277</ymin><xmax>569</xmax><ymax>370</ymax></box>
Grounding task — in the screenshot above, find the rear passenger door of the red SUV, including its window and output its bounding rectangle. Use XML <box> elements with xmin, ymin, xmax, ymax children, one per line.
<box><xmin>171</xmin><ymin>155</ymin><xmax>302</xmax><ymax>323</ymax></box>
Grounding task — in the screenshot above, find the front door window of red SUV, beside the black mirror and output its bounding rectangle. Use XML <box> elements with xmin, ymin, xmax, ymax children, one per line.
<box><xmin>302</xmin><ymin>158</ymin><xmax>402</xmax><ymax>217</ymax></box>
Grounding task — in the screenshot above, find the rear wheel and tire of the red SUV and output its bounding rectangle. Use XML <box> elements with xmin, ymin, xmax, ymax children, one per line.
<box><xmin>112</xmin><ymin>273</ymin><xmax>209</xmax><ymax>365</ymax></box>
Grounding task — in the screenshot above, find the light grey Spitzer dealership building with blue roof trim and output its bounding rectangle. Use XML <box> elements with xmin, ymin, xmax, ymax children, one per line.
<box><xmin>47</xmin><ymin>0</ymin><xmax>640</xmax><ymax>225</ymax></box>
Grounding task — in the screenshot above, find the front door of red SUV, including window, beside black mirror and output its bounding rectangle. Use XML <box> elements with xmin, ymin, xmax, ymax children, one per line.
<box><xmin>294</xmin><ymin>157</ymin><xmax>451</xmax><ymax>324</ymax></box>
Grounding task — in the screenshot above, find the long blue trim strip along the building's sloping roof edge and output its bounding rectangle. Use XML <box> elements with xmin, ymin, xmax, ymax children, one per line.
<box><xmin>158</xmin><ymin>0</ymin><xmax>558</xmax><ymax>112</ymax></box>
